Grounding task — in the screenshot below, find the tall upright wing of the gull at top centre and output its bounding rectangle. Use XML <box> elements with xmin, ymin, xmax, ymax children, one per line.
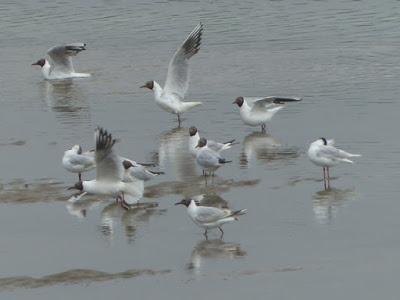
<box><xmin>164</xmin><ymin>23</ymin><xmax>203</xmax><ymax>99</ymax></box>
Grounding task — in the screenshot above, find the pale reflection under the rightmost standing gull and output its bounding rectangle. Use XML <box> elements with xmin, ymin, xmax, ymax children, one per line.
<box><xmin>313</xmin><ymin>189</ymin><xmax>356</xmax><ymax>224</ymax></box>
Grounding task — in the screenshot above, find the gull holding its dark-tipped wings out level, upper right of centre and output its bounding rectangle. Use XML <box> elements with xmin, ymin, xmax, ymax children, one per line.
<box><xmin>233</xmin><ymin>96</ymin><xmax>302</xmax><ymax>132</ymax></box>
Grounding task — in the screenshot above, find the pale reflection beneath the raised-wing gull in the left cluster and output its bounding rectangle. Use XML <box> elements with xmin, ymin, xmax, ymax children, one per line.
<box><xmin>100</xmin><ymin>202</ymin><xmax>165</xmax><ymax>243</ymax></box>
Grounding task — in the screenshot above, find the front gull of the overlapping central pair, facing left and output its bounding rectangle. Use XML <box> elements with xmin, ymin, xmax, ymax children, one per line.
<box><xmin>196</xmin><ymin>138</ymin><xmax>232</xmax><ymax>176</ymax></box>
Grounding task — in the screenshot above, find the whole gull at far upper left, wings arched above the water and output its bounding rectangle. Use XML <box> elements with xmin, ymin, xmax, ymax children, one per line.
<box><xmin>32</xmin><ymin>43</ymin><xmax>90</xmax><ymax>80</ymax></box>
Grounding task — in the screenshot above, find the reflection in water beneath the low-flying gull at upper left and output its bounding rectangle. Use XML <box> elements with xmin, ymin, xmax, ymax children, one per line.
<box><xmin>41</xmin><ymin>80</ymin><xmax>92</xmax><ymax>128</ymax></box>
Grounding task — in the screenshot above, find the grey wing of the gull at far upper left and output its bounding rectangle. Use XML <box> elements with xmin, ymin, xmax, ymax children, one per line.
<box><xmin>47</xmin><ymin>43</ymin><xmax>86</xmax><ymax>72</ymax></box>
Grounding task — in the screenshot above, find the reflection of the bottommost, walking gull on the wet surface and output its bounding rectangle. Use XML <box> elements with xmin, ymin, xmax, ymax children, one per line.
<box><xmin>186</xmin><ymin>239</ymin><xmax>246</xmax><ymax>274</ymax></box>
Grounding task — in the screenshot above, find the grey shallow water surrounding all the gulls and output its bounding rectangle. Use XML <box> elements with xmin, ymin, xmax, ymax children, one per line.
<box><xmin>0</xmin><ymin>0</ymin><xmax>400</xmax><ymax>299</ymax></box>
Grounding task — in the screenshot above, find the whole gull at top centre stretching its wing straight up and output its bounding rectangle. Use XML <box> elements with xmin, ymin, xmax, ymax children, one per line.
<box><xmin>141</xmin><ymin>23</ymin><xmax>203</xmax><ymax>126</ymax></box>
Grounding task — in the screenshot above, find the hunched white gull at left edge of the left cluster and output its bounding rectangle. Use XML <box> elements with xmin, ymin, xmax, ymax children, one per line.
<box><xmin>62</xmin><ymin>145</ymin><xmax>96</xmax><ymax>181</ymax></box>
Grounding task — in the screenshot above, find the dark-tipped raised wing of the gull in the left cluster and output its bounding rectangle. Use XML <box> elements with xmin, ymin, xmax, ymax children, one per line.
<box><xmin>95</xmin><ymin>128</ymin><xmax>123</xmax><ymax>181</ymax></box>
